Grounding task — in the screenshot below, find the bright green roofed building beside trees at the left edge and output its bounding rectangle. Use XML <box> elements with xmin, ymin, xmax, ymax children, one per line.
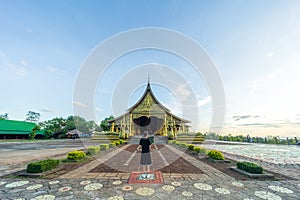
<box><xmin>0</xmin><ymin>120</ymin><xmax>44</xmax><ymax>139</ymax></box>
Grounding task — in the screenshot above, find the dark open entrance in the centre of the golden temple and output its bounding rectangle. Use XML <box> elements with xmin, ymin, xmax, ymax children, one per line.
<box><xmin>133</xmin><ymin>116</ymin><xmax>164</xmax><ymax>135</ymax></box>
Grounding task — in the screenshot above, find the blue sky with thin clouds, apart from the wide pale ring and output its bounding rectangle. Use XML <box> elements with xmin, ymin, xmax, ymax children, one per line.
<box><xmin>0</xmin><ymin>0</ymin><xmax>300</xmax><ymax>137</ymax></box>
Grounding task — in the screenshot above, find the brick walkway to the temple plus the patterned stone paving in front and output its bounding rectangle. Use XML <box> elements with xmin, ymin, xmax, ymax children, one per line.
<box><xmin>0</xmin><ymin>145</ymin><xmax>300</xmax><ymax>200</ymax></box>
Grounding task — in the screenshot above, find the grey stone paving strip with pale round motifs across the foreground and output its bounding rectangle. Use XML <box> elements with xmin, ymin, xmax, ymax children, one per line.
<box><xmin>0</xmin><ymin>179</ymin><xmax>300</xmax><ymax>199</ymax></box>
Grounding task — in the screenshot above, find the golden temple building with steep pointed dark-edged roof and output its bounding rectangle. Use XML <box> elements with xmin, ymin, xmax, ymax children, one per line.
<box><xmin>108</xmin><ymin>81</ymin><xmax>190</xmax><ymax>136</ymax></box>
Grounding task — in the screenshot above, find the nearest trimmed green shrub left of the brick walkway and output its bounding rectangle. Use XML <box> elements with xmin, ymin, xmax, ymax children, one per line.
<box><xmin>26</xmin><ymin>159</ymin><xmax>59</xmax><ymax>173</ymax></box>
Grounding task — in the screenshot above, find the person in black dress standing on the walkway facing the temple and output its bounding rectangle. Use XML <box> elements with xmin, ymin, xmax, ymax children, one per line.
<box><xmin>137</xmin><ymin>131</ymin><xmax>152</xmax><ymax>173</ymax></box>
